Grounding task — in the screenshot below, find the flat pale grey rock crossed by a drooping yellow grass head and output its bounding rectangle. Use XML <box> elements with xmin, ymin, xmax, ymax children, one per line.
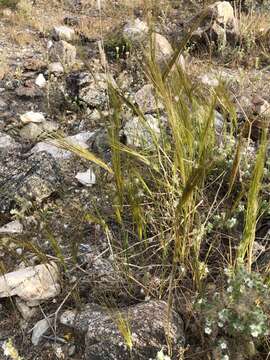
<box><xmin>31</xmin><ymin>131</ymin><xmax>94</xmax><ymax>160</ymax></box>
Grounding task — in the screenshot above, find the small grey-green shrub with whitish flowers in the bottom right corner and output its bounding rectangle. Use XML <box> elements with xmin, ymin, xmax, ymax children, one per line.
<box><xmin>195</xmin><ymin>266</ymin><xmax>270</xmax><ymax>355</ymax></box>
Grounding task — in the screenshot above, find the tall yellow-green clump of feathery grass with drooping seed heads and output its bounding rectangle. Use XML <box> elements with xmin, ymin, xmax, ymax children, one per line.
<box><xmin>53</xmin><ymin>16</ymin><xmax>269</xmax><ymax>355</ymax></box>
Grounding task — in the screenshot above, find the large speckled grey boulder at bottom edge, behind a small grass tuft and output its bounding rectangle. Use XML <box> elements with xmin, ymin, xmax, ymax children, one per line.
<box><xmin>61</xmin><ymin>300</ymin><xmax>185</xmax><ymax>360</ymax></box>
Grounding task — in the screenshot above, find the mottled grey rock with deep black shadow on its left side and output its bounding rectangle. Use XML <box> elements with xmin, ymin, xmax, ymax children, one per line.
<box><xmin>66</xmin><ymin>72</ymin><xmax>108</xmax><ymax>108</ymax></box>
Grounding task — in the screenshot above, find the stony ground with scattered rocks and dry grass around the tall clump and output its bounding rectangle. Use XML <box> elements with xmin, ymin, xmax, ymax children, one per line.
<box><xmin>0</xmin><ymin>0</ymin><xmax>270</xmax><ymax>360</ymax></box>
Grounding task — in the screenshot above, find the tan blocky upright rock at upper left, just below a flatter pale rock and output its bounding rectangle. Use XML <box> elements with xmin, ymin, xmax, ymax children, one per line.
<box><xmin>49</xmin><ymin>40</ymin><xmax>77</xmax><ymax>67</ymax></box>
